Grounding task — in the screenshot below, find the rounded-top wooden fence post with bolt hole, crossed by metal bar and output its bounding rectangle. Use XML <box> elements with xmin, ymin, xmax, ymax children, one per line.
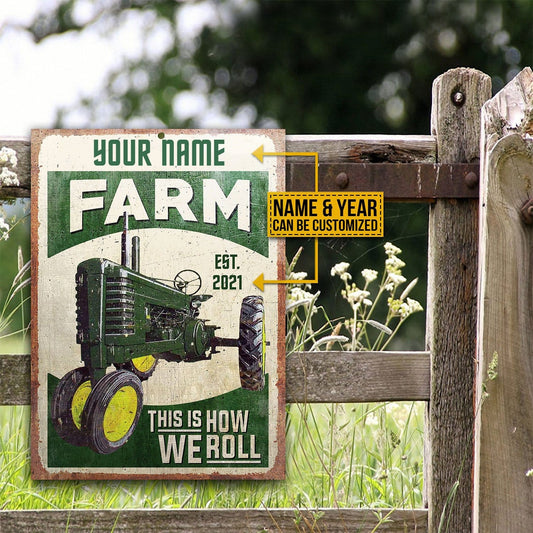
<box><xmin>425</xmin><ymin>68</ymin><xmax>491</xmax><ymax>533</ymax></box>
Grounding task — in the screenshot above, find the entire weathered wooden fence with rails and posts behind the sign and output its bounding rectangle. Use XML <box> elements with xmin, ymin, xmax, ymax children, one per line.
<box><xmin>0</xmin><ymin>69</ymin><xmax>533</xmax><ymax>533</ymax></box>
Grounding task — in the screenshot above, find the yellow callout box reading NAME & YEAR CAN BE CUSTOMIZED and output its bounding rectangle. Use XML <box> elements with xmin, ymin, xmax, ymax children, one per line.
<box><xmin>268</xmin><ymin>192</ymin><xmax>383</xmax><ymax>237</ymax></box>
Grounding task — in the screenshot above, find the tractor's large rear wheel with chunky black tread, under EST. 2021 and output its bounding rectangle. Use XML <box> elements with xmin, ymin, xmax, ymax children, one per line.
<box><xmin>239</xmin><ymin>296</ymin><xmax>266</xmax><ymax>391</ymax></box>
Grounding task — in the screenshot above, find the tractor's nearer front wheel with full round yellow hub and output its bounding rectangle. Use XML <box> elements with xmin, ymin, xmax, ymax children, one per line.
<box><xmin>82</xmin><ymin>370</ymin><xmax>143</xmax><ymax>454</ymax></box>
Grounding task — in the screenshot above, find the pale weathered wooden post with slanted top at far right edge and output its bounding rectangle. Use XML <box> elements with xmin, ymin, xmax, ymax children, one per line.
<box><xmin>473</xmin><ymin>68</ymin><xmax>533</xmax><ymax>533</ymax></box>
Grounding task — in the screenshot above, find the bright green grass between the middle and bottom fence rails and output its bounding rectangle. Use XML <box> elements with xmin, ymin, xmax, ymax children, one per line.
<box><xmin>0</xmin><ymin>403</ymin><xmax>423</xmax><ymax>510</ymax></box>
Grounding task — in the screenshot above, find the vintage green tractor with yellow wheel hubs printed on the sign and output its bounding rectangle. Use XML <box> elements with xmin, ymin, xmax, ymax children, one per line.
<box><xmin>51</xmin><ymin>214</ymin><xmax>266</xmax><ymax>454</ymax></box>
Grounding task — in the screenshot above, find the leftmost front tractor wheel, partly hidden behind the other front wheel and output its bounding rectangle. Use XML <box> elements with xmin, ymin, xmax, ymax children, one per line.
<box><xmin>51</xmin><ymin>366</ymin><xmax>92</xmax><ymax>446</ymax></box>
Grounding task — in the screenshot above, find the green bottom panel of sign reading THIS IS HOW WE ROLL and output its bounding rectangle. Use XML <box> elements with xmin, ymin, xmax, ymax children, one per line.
<box><xmin>48</xmin><ymin>374</ymin><xmax>269</xmax><ymax>472</ymax></box>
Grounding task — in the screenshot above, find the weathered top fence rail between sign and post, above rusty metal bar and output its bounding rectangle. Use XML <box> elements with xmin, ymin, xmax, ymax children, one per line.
<box><xmin>286</xmin><ymin>135</ymin><xmax>436</xmax><ymax>163</ymax></box>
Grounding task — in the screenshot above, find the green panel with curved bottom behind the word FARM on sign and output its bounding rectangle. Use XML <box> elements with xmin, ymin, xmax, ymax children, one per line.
<box><xmin>48</xmin><ymin>171</ymin><xmax>268</xmax><ymax>257</ymax></box>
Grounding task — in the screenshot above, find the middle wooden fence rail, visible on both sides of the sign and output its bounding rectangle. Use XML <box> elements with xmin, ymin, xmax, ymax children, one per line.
<box><xmin>0</xmin><ymin>352</ymin><xmax>429</xmax><ymax>405</ymax></box>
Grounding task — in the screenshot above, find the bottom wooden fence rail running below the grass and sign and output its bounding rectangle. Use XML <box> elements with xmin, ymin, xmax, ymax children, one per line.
<box><xmin>0</xmin><ymin>509</ymin><xmax>428</xmax><ymax>533</ymax></box>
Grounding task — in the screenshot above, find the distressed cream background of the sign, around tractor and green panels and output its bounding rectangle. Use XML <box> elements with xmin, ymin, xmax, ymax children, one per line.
<box><xmin>33</xmin><ymin>130</ymin><xmax>284</xmax><ymax>475</ymax></box>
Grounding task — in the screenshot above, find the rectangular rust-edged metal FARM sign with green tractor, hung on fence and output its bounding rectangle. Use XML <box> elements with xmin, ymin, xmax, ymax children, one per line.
<box><xmin>31</xmin><ymin>130</ymin><xmax>285</xmax><ymax>479</ymax></box>
